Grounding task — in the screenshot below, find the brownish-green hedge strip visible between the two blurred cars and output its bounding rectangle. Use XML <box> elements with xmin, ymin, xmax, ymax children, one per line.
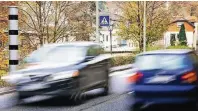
<box><xmin>111</xmin><ymin>55</ymin><xmax>135</xmax><ymax>67</ymax></box>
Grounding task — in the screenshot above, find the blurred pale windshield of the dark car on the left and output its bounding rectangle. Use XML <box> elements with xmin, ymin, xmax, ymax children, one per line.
<box><xmin>24</xmin><ymin>46</ymin><xmax>86</xmax><ymax>63</ymax></box>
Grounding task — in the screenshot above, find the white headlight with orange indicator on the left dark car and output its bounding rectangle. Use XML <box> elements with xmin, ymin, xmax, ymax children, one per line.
<box><xmin>46</xmin><ymin>70</ymin><xmax>79</xmax><ymax>81</ymax></box>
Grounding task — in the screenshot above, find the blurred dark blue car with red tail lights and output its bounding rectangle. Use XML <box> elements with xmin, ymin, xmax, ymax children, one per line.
<box><xmin>128</xmin><ymin>49</ymin><xmax>198</xmax><ymax>110</ymax></box>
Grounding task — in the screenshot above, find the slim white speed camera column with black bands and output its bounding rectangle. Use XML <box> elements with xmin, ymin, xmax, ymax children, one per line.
<box><xmin>8</xmin><ymin>6</ymin><xmax>18</xmax><ymax>72</ymax></box>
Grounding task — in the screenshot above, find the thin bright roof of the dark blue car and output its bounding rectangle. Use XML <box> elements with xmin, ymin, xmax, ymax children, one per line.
<box><xmin>138</xmin><ymin>49</ymin><xmax>193</xmax><ymax>56</ymax></box>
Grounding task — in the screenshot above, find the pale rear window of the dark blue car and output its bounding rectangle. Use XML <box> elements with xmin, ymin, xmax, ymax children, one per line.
<box><xmin>135</xmin><ymin>55</ymin><xmax>191</xmax><ymax>70</ymax></box>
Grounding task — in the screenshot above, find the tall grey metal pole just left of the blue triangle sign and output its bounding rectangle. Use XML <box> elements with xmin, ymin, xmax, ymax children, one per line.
<box><xmin>96</xmin><ymin>1</ymin><xmax>100</xmax><ymax>43</ymax></box>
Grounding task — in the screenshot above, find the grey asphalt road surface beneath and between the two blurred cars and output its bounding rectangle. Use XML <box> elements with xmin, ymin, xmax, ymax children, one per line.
<box><xmin>0</xmin><ymin>68</ymin><xmax>193</xmax><ymax>111</ymax></box>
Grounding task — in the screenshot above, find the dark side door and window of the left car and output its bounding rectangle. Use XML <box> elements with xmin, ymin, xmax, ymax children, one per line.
<box><xmin>81</xmin><ymin>45</ymin><xmax>108</xmax><ymax>89</ymax></box>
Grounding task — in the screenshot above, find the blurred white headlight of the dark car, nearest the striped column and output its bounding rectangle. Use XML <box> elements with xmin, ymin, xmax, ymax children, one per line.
<box><xmin>1</xmin><ymin>74</ymin><xmax>23</xmax><ymax>83</ymax></box>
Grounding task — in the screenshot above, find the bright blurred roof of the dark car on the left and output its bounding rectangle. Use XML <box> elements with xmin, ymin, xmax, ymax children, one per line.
<box><xmin>44</xmin><ymin>41</ymin><xmax>99</xmax><ymax>47</ymax></box>
